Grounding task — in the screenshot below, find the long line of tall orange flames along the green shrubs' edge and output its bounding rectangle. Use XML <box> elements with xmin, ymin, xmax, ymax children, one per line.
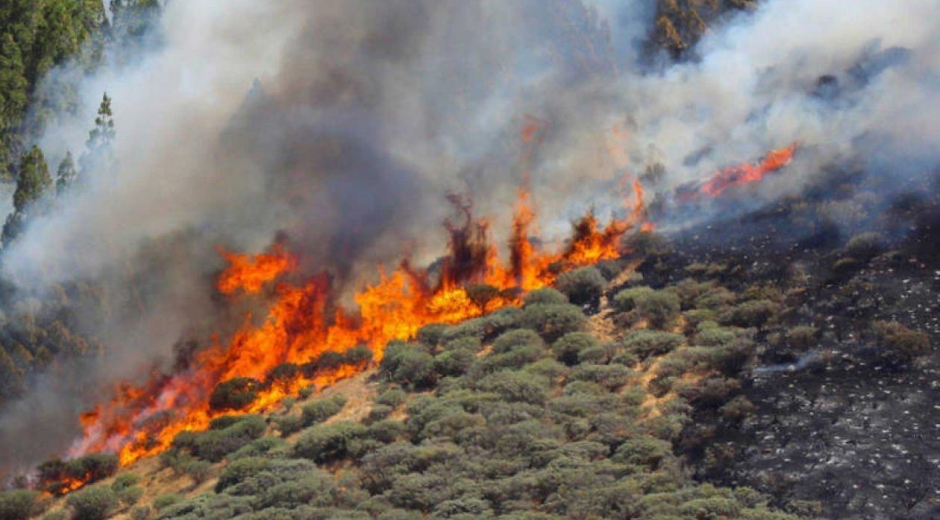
<box><xmin>58</xmin><ymin>164</ymin><xmax>649</xmax><ymax>484</ymax></box>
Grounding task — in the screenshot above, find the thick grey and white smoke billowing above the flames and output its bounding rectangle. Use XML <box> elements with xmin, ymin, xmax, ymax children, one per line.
<box><xmin>0</xmin><ymin>0</ymin><xmax>940</xmax><ymax>476</ymax></box>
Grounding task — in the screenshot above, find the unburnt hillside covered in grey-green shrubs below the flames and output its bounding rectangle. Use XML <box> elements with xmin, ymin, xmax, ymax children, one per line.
<box><xmin>20</xmin><ymin>256</ymin><xmax>816</xmax><ymax>520</ymax></box>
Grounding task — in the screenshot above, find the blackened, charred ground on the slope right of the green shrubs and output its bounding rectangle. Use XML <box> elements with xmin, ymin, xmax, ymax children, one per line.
<box><xmin>644</xmin><ymin>181</ymin><xmax>940</xmax><ymax>520</ymax></box>
